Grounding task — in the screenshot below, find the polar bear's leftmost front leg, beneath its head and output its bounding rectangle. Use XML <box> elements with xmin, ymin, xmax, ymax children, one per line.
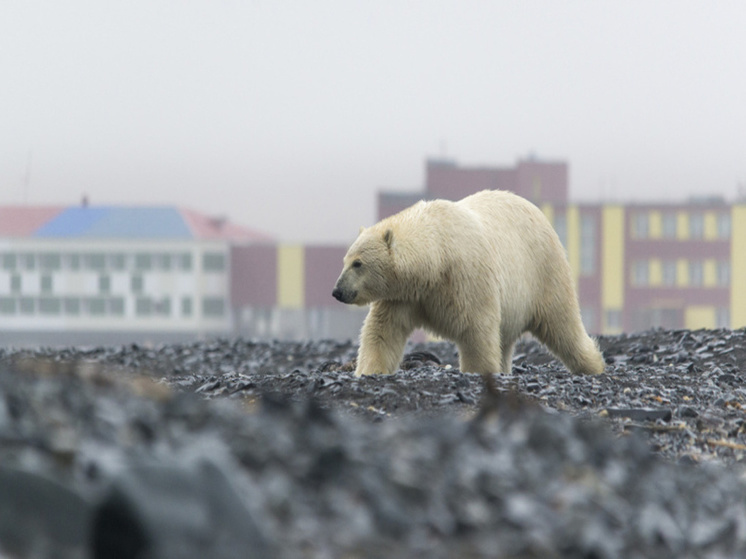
<box><xmin>355</xmin><ymin>301</ymin><xmax>414</xmax><ymax>377</ymax></box>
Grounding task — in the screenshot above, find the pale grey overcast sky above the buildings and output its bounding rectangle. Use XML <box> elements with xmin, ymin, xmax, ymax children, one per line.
<box><xmin>0</xmin><ymin>0</ymin><xmax>746</xmax><ymax>242</ymax></box>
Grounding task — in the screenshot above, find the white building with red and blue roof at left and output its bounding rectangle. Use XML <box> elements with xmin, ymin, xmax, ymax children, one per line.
<box><xmin>0</xmin><ymin>206</ymin><xmax>269</xmax><ymax>345</ymax></box>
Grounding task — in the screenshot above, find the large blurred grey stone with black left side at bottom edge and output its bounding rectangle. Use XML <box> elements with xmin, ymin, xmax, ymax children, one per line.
<box><xmin>92</xmin><ymin>462</ymin><xmax>276</xmax><ymax>559</ymax></box>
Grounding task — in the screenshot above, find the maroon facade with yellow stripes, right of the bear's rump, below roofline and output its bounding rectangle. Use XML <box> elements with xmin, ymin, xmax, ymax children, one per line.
<box><xmin>560</xmin><ymin>202</ymin><xmax>746</xmax><ymax>334</ymax></box>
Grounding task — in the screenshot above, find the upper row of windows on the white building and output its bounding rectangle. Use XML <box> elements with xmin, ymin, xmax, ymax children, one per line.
<box><xmin>0</xmin><ymin>252</ymin><xmax>226</xmax><ymax>272</ymax></box>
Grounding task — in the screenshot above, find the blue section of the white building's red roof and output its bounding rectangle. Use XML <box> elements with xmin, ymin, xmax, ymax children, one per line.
<box><xmin>34</xmin><ymin>206</ymin><xmax>193</xmax><ymax>239</ymax></box>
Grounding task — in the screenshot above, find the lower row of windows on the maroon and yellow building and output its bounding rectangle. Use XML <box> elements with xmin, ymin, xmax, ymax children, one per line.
<box><xmin>630</xmin><ymin>260</ymin><xmax>731</xmax><ymax>287</ymax></box>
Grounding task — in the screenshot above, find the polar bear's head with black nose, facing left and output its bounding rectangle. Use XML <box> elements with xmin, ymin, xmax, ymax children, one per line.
<box><xmin>332</xmin><ymin>226</ymin><xmax>394</xmax><ymax>305</ymax></box>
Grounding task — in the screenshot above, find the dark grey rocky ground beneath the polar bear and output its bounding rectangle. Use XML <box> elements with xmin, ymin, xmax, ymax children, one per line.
<box><xmin>0</xmin><ymin>330</ymin><xmax>746</xmax><ymax>558</ymax></box>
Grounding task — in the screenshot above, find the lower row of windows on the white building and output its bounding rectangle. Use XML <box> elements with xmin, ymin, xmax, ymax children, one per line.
<box><xmin>0</xmin><ymin>297</ymin><xmax>226</xmax><ymax>318</ymax></box>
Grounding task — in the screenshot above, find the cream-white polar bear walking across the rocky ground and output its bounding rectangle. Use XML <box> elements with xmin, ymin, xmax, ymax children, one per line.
<box><xmin>332</xmin><ymin>190</ymin><xmax>604</xmax><ymax>376</ymax></box>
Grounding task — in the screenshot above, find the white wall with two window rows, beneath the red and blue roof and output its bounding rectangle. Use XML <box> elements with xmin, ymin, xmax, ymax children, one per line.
<box><xmin>0</xmin><ymin>238</ymin><xmax>231</xmax><ymax>344</ymax></box>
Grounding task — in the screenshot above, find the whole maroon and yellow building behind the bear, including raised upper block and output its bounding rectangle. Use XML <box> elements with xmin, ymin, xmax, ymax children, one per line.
<box><xmin>378</xmin><ymin>158</ymin><xmax>746</xmax><ymax>333</ymax></box>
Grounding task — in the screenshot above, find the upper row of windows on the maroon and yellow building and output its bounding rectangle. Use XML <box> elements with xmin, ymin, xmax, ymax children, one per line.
<box><xmin>632</xmin><ymin>211</ymin><xmax>731</xmax><ymax>240</ymax></box>
